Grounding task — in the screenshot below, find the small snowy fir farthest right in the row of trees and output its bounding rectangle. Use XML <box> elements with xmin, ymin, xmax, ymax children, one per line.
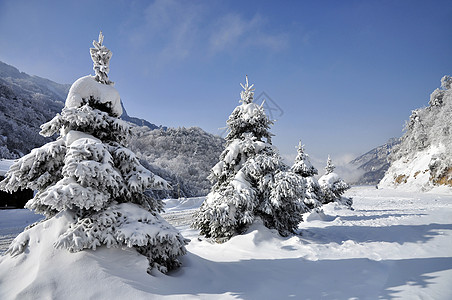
<box><xmin>319</xmin><ymin>155</ymin><xmax>353</xmax><ymax>207</ymax></box>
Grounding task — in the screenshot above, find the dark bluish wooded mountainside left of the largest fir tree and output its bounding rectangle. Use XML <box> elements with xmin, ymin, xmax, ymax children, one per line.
<box><xmin>0</xmin><ymin>62</ymin><xmax>70</xmax><ymax>158</ymax></box>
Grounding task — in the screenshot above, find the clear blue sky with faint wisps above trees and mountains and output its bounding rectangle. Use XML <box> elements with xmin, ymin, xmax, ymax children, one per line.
<box><xmin>0</xmin><ymin>0</ymin><xmax>452</xmax><ymax>167</ymax></box>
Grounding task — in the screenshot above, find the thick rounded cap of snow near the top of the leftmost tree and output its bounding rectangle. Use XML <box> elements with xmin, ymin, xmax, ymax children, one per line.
<box><xmin>65</xmin><ymin>75</ymin><xmax>122</xmax><ymax>117</ymax></box>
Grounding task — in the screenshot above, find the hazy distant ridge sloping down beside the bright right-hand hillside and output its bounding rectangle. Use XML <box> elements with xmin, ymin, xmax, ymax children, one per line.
<box><xmin>349</xmin><ymin>138</ymin><xmax>400</xmax><ymax>185</ymax></box>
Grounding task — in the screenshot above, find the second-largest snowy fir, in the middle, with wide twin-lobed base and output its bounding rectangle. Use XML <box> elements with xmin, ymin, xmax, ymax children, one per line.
<box><xmin>193</xmin><ymin>77</ymin><xmax>307</xmax><ymax>242</ymax></box>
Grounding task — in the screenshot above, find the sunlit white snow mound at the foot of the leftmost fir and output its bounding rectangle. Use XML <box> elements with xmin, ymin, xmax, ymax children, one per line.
<box><xmin>0</xmin><ymin>212</ymin><xmax>157</xmax><ymax>299</ymax></box>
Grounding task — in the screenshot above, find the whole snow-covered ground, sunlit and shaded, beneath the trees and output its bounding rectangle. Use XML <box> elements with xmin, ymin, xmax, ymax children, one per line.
<box><xmin>0</xmin><ymin>187</ymin><xmax>452</xmax><ymax>299</ymax></box>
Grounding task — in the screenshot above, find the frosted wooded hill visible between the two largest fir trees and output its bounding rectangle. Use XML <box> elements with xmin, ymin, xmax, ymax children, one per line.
<box><xmin>129</xmin><ymin>127</ymin><xmax>224</xmax><ymax>198</ymax></box>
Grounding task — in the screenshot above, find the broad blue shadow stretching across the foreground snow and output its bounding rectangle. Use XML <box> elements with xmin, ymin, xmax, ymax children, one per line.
<box><xmin>92</xmin><ymin>253</ymin><xmax>452</xmax><ymax>299</ymax></box>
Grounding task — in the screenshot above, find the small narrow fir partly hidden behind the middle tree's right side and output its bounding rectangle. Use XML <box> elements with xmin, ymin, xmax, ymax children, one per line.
<box><xmin>290</xmin><ymin>141</ymin><xmax>323</xmax><ymax>209</ymax></box>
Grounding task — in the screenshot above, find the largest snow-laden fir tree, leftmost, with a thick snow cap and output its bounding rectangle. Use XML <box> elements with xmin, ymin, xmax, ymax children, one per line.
<box><xmin>0</xmin><ymin>33</ymin><xmax>187</xmax><ymax>272</ymax></box>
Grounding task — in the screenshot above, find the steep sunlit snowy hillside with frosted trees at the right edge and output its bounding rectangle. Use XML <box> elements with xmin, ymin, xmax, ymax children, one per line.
<box><xmin>379</xmin><ymin>76</ymin><xmax>452</xmax><ymax>191</ymax></box>
